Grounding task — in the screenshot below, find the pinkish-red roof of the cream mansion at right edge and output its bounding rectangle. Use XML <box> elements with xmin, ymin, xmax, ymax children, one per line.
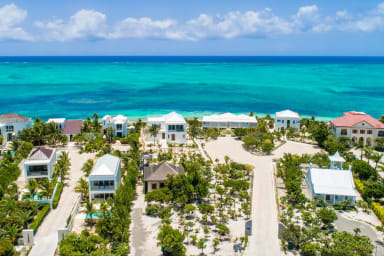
<box><xmin>330</xmin><ymin>111</ymin><xmax>384</xmax><ymax>129</ymax></box>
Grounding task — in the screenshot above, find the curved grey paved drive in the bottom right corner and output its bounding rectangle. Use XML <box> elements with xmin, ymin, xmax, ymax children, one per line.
<box><xmin>335</xmin><ymin>213</ymin><xmax>384</xmax><ymax>255</ymax></box>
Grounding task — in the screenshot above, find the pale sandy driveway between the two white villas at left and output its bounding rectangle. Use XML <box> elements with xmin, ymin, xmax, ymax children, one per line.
<box><xmin>29</xmin><ymin>148</ymin><xmax>91</xmax><ymax>256</ymax></box>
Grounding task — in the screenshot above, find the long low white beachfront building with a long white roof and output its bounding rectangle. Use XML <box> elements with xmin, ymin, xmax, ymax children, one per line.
<box><xmin>203</xmin><ymin>113</ymin><xmax>257</xmax><ymax>129</ymax></box>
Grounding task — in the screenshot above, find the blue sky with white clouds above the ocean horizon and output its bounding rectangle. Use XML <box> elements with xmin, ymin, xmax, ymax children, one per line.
<box><xmin>0</xmin><ymin>0</ymin><xmax>384</xmax><ymax>56</ymax></box>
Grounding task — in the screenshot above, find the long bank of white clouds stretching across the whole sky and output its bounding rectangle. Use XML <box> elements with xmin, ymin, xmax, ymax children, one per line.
<box><xmin>0</xmin><ymin>2</ymin><xmax>384</xmax><ymax>42</ymax></box>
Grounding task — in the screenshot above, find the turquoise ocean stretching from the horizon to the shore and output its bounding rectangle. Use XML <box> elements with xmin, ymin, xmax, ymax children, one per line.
<box><xmin>0</xmin><ymin>57</ymin><xmax>384</xmax><ymax>120</ymax></box>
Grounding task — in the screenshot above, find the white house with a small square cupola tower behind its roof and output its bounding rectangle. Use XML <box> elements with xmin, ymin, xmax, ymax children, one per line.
<box><xmin>306</xmin><ymin>152</ymin><xmax>356</xmax><ymax>205</ymax></box>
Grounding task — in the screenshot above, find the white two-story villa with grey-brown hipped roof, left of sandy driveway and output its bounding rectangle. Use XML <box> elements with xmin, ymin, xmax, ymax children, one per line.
<box><xmin>24</xmin><ymin>147</ymin><xmax>56</xmax><ymax>179</ymax></box>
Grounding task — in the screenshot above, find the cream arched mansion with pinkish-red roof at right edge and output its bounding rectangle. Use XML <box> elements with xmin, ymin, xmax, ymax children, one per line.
<box><xmin>329</xmin><ymin>111</ymin><xmax>384</xmax><ymax>147</ymax></box>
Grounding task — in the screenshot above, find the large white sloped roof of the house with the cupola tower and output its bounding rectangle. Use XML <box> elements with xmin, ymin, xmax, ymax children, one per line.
<box><xmin>308</xmin><ymin>168</ymin><xmax>356</xmax><ymax>196</ymax></box>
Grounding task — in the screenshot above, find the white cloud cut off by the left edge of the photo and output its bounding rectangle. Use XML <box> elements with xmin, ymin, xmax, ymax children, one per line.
<box><xmin>0</xmin><ymin>4</ymin><xmax>32</xmax><ymax>40</ymax></box>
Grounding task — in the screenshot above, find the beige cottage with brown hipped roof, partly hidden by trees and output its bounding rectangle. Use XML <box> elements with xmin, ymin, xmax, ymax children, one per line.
<box><xmin>144</xmin><ymin>163</ymin><xmax>184</xmax><ymax>192</ymax></box>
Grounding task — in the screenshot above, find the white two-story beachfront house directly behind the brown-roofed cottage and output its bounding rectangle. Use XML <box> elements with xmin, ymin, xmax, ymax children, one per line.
<box><xmin>147</xmin><ymin>112</ymin><xmax>187</xmax><ymax>144</ymax></box>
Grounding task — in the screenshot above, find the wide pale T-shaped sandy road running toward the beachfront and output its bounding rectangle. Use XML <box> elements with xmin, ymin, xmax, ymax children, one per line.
<box><xmin>206</xmin><ymin>137</ymin><xmax>319</xmax><ymax>256</ymax></box>
